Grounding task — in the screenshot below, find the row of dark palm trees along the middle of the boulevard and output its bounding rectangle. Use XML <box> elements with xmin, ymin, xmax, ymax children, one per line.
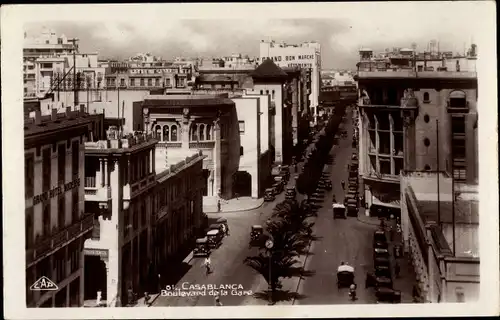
<box><xmin>244</xmin><ymin>109</ymin><xmax>344</xmax><ymax>303</ymax></box>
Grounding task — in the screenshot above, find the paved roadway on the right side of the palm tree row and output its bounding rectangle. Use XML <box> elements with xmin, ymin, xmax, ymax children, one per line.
<box><xmin>295</xmin><ymin>106</ymin><xmax>376</xmax><ymax>305</ymax></box>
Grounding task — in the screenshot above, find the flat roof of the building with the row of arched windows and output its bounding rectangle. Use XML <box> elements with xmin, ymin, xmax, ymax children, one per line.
<box><xmin>142</xmin><ymin>94</ymin><xmax>234</xmax><ymax>107</ymax></box>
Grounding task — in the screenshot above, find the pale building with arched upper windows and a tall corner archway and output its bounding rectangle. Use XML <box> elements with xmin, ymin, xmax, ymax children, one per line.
<box><xmin>142</xmin><ymin>95</ymin><xmax>240</xmax><ymax>199</ymax></box>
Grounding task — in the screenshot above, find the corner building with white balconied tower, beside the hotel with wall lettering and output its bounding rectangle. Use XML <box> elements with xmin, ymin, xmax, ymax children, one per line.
<box><xmin>85</xmin><ymin>129</ymin><xmax>203</xmax><ymax>307</ymax></box>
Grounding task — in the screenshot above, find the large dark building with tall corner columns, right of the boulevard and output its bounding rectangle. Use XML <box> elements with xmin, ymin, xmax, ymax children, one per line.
<box><xmin>358</xmin><ymin>45</ymin><xmax>478</xmax><ymax>219</ymax></box>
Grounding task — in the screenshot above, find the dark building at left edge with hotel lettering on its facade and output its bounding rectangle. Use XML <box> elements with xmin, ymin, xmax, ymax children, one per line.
<box><xmin>24</xmin><ymin>108</ymin><xmax>102</xmax><ymax>308</ymax></box>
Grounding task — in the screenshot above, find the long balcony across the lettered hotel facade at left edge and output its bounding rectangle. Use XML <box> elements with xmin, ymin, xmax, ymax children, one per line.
<box><xmin>26</xmin><ymin>214</ymin><xmax>94</xmax><ymax>267</ymax></box>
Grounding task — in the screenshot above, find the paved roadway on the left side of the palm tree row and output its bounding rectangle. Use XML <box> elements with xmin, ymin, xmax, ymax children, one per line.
<box><xmin>153</xmin><ymin>139</ymin><xmax>316</xmax><ymax>306</ymax></box>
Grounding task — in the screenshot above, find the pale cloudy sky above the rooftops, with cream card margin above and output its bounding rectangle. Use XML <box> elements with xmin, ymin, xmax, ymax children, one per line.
<box><xmin>20</xmin><ymin>2</ymin><xmax>494</xmax><ymax>69</ymax></box>
